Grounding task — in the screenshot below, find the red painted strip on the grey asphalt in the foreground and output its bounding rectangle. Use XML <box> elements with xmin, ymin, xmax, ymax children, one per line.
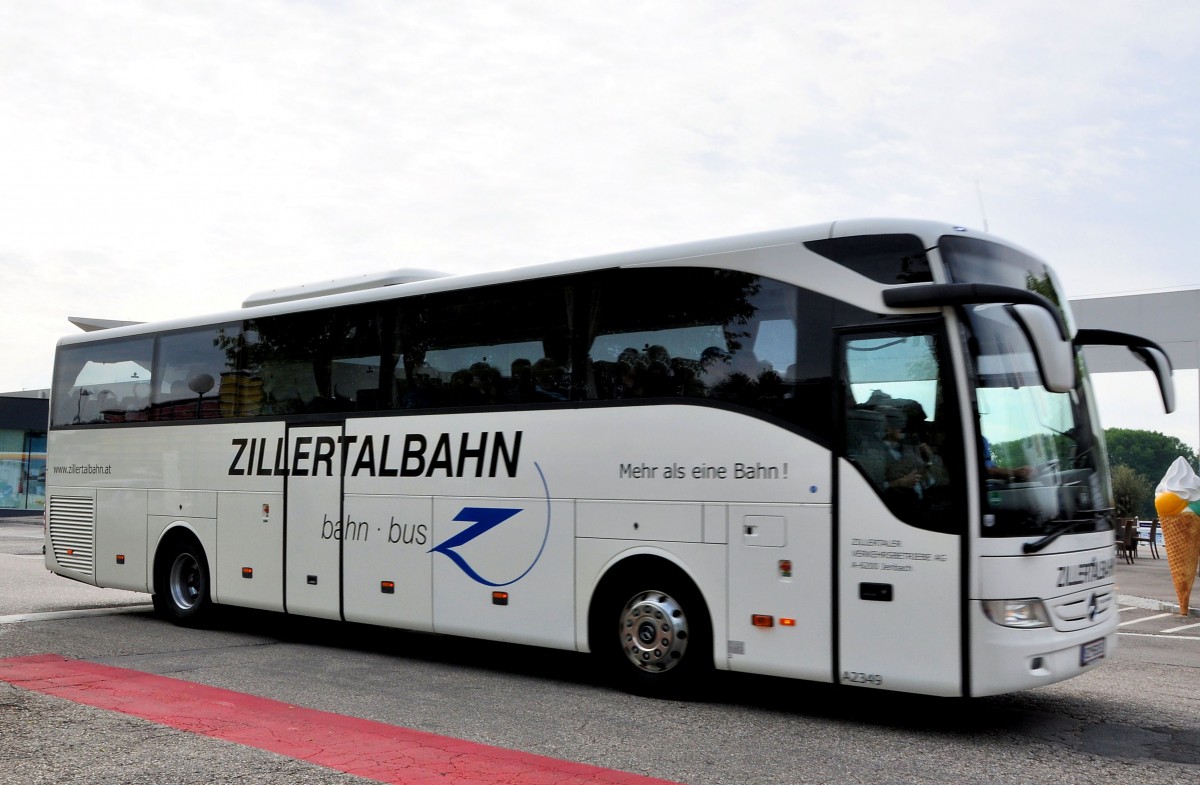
<box><xmin>0</xmin><ymin>654</ymin><xmax>674</xmax><ymax>785</ymax></box>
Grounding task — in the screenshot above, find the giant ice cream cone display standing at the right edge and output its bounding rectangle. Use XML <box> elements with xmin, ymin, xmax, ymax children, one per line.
<box><xmin>1154</xmin><ymin>456</ymin><xmax>1200</xmax><ymax>616</ymax></box>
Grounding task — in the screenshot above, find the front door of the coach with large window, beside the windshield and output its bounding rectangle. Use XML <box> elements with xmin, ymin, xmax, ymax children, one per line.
<box><xmin>835</xmin><ymin>320</ymin><xmax>966</xmax><ymax>696</ymax></box>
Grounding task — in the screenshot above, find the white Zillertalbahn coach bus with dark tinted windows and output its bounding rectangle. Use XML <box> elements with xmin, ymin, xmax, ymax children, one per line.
<box><xmin>46</xmin><ymin>220</ymin><xmax>1174</xmax><ymax>696</ymax></box>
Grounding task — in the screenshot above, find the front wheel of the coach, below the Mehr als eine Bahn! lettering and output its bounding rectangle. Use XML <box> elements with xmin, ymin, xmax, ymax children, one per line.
<box><xmin>588</xmin><ymin>559</ymin><xmax>713</xmax><ymax>699</ymax></box>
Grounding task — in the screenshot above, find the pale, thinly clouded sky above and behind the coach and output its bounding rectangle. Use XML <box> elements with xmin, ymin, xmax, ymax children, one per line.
<box><xmin>0</xmin><ymin>0</ymin><xmax>1200</xmax><ymax>449</ymax></box>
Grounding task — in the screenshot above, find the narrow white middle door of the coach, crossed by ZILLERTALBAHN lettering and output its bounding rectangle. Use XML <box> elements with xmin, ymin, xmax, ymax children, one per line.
<box><xmin>283</xmin><ymin>425</ymin><xmax>344</xmax><ymax>619</ymax></box>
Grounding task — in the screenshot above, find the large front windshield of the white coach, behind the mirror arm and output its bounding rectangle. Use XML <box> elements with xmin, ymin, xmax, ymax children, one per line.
<box><xmin>942</xmin><ymin>238</ymin><xmax>1112</xmax><ymax>537</ymax></box>
